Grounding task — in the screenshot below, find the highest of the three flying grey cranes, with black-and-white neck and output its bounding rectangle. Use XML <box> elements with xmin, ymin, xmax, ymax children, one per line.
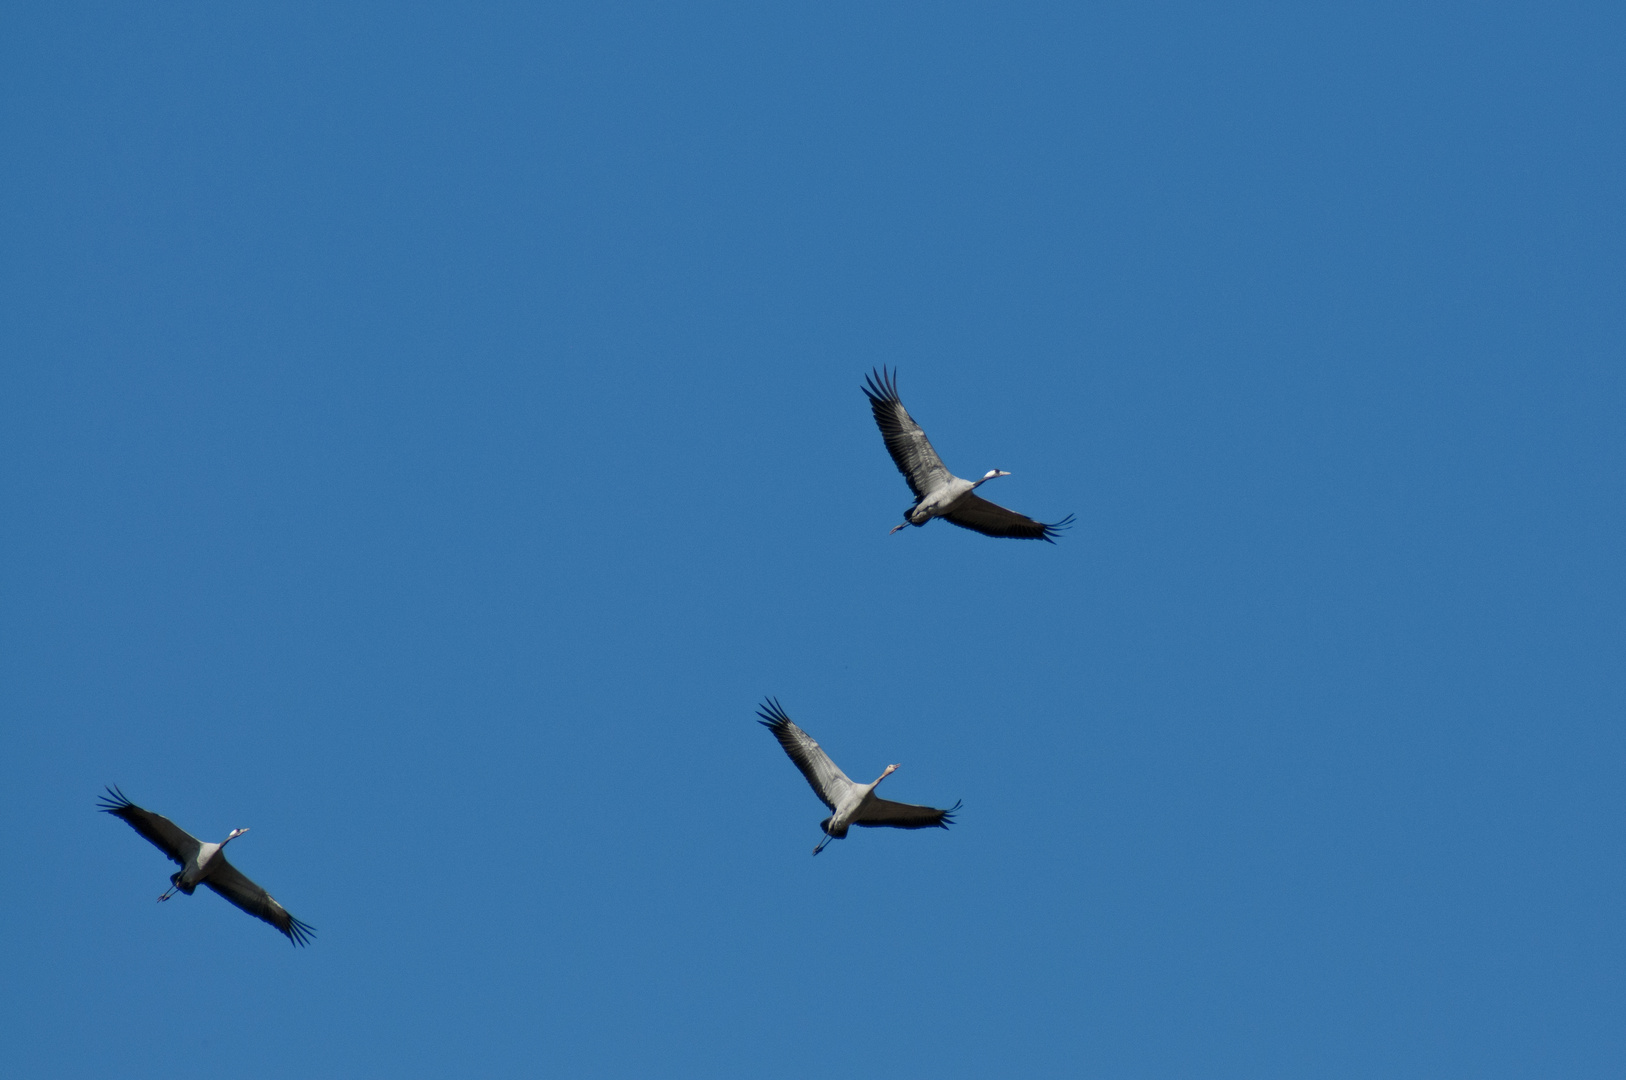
<box><xmin>863</xmin><ymin>368</ymin><xmax>1073</xmax><ymax>543</ymax></box>
